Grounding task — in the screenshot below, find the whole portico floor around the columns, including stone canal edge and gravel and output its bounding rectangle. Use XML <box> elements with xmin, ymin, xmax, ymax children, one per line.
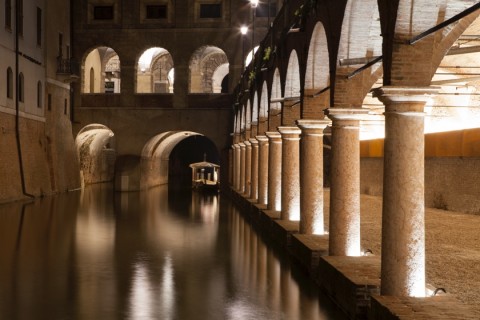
<box><xmin>228</xmin><ymin>189</ymin><xmax>480</xmax><ymax>319</ymax></box>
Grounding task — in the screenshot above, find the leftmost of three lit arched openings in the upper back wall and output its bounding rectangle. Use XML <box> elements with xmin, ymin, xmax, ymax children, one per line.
<box><xmin>81</xmin><ymin>46</ymin><xmax>121</xmax><ymax>93</ymax></box>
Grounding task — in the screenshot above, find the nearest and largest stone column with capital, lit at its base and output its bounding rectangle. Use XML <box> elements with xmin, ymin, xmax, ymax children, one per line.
<box><xmin>374</xmin><ymin>87</ymin><xmax>438</xmax><ymax>297</ymax></box>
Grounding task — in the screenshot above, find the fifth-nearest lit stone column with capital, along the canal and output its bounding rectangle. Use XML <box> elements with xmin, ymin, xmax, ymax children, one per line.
<box><xmin>266</xmin><ymin>131</ymin><xmax>282</xmax><ymax>211</ymax></box>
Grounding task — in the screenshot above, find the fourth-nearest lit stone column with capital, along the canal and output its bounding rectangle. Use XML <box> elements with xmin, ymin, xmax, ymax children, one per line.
<box><xmin>278</xmin><ymin>127</ymin><xmax>302</xmax><ymax>221</ymax></box>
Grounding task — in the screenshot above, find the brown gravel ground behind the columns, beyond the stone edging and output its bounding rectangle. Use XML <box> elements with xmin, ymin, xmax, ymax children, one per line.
<box><xmin>325</xmin><ymin>191</ymin><xmax>480</xmax><ymax>314</ymax></box>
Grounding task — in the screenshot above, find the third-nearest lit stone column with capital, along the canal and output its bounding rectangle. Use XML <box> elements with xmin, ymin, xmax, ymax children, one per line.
<box><xmin>297</xmin><ymin>120</ymin><xmax>330</xmax><ymax>234</ymax></box>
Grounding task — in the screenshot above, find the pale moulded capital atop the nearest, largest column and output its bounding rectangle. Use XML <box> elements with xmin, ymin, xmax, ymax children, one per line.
<box><xmin>372</xmin><ymin>86</ymin><xmax>440</xmax><ymax>112</ymax></box>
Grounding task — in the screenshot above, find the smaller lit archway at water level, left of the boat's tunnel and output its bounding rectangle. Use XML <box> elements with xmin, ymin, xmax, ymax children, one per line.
<box><xmin>75</xmin><ymin>123</ymin><xmax>116</xmax><ymax>184</ymax></box>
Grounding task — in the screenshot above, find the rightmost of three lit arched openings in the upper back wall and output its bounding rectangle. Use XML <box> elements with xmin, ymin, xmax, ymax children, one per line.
<box><xmin>189</xmin><ymin>46</ymin><xmax>229</xmax><ymax>93</ymax></box>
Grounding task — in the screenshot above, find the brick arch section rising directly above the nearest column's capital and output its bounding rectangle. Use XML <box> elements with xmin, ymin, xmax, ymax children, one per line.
<box><xmin>379</xmin><ymin>0</ymin><xmax>478</xmax><ymax>86</ymax></box>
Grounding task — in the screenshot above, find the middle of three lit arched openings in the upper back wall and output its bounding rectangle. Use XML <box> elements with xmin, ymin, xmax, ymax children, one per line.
<box><xmin>136</xmin><ymin>47</ymin><xmax>174</xmax><ymax>93</ymax></box>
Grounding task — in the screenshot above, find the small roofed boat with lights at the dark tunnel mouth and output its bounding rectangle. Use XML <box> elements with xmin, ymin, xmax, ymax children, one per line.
<box><xmin>189</xmin><ymin>157</ymin><xmax>220</xmax><ymax>191</ymax></box>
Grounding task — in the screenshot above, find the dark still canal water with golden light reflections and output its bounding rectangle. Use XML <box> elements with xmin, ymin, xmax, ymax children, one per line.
<box><xmin>0</xmin><ymin>184</ymin><xmax>345</xmax><ymax>320</ymax></box>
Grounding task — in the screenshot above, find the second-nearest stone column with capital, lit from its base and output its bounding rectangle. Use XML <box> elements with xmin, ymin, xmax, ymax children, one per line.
<box><xmin>327</xmin><ymin>108</ymin><xmax>368</xmax><ymax>256</ymax></box>
